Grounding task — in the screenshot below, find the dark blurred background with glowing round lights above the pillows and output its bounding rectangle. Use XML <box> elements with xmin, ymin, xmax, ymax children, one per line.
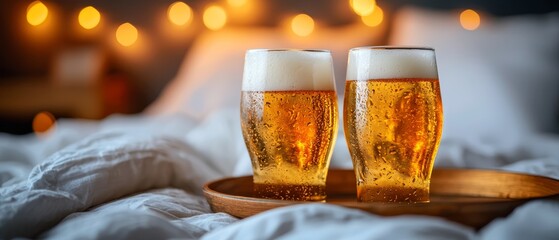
<box><xmin>0</xmin><ymin>0</ymin><xmax>559</xmax><ymax>134</ymax></box>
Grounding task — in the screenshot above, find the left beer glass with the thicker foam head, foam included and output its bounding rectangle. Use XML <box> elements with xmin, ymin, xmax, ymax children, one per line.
<box><xmin>241</xmin><ymin>49</ymin><xmax>338</xmax><ymax>201</ymax></box>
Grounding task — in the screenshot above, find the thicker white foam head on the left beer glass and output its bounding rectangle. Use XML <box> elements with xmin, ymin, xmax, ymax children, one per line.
<box><xmin>242</xmin><ymin>49</ymin><xmax>335</xmax><ymax>91</ymax></box>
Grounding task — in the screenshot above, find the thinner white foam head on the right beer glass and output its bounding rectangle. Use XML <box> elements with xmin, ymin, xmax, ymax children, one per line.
<box><xmin>346</xmin><ymin>46</ymin><xmax>438</xmax><ymax>81</ymax></box>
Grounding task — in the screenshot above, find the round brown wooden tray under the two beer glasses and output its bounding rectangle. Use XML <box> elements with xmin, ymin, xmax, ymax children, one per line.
<box><xmin>204</xmin><ymin>169</ymin><xmax>559</xmax><ymax>229</ymax></box>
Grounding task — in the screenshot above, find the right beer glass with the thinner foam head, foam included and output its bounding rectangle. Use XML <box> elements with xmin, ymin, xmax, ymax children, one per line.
<box><xmin>344</xmin><ymin>46</ymin><xmax>443</xmax><ymax>203</ymax></box>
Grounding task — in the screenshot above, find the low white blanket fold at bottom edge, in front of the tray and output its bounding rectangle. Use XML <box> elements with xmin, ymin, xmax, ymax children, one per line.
<box><xmin>203</xmin><ymin>204</ymin><xmax>474</xmax><ymax>240</ymax></box>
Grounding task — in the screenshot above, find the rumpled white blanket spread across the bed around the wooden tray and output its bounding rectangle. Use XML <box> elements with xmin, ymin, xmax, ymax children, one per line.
<box><xmin>0</xmin><ymin>111</ymin><xmax>559</xmax><ymax>239</ymax></box>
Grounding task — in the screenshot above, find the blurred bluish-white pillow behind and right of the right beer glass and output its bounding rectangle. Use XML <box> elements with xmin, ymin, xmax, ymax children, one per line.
<box><xmin>390</xmin><ymin>8</ymin><xmax>559</xmax><ymax>141</ymax></box>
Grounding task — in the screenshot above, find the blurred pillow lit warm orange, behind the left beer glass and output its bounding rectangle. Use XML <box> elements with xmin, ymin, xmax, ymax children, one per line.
<box><xmin>146</xmin><ymin>22</ymin><xmax>385</xmax><ymax>118</ymax></box>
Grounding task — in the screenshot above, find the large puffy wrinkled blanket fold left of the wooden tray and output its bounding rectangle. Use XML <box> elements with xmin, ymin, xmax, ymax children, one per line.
<box><xmin>0</xmin><ymin>115</ymin><xmax>220</xmax><ymax>237</ymax></box>
